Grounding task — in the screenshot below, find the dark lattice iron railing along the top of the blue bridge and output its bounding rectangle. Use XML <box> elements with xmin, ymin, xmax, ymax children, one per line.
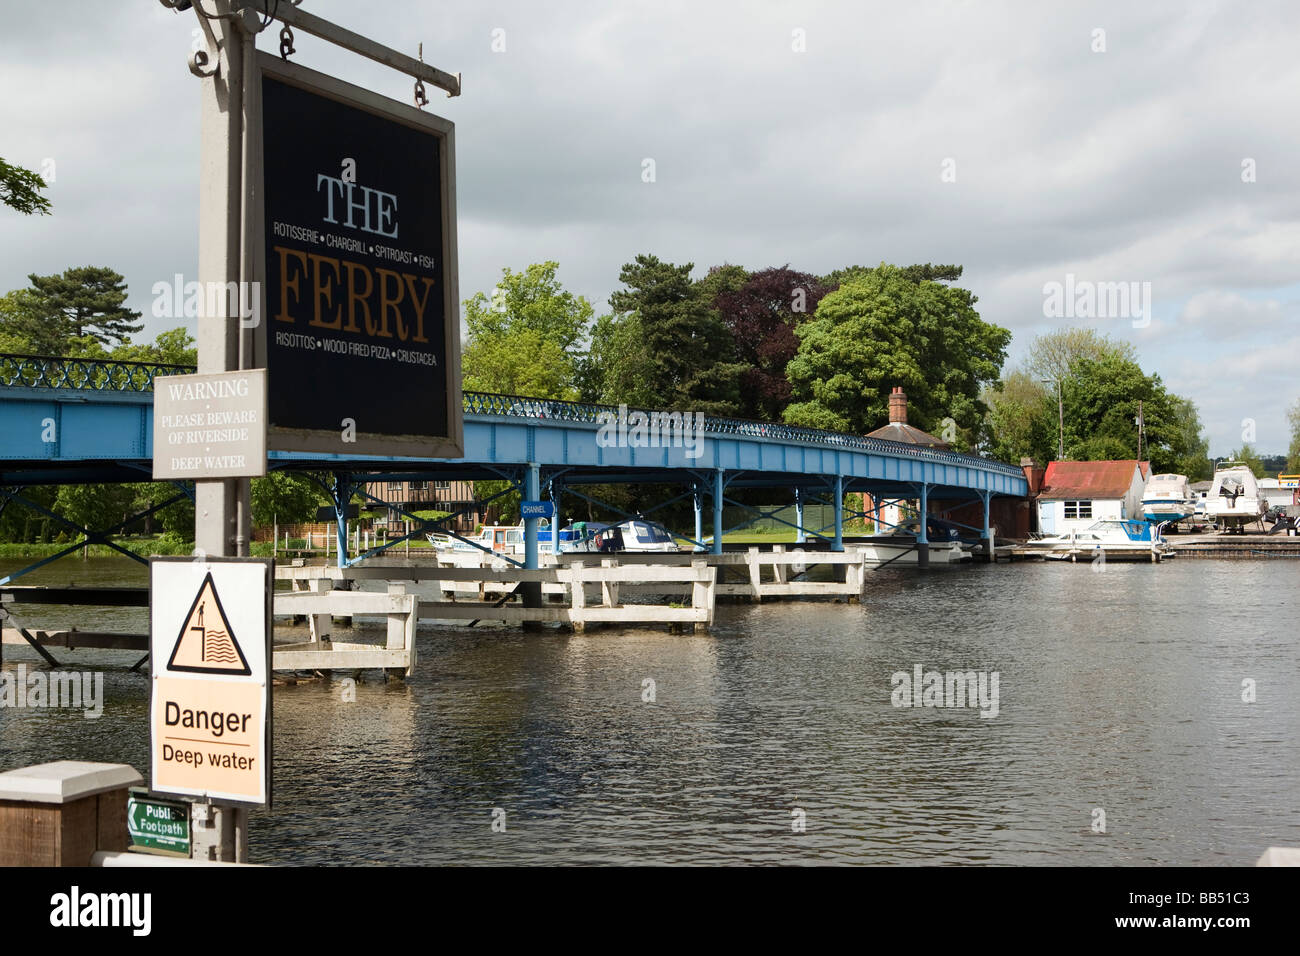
<box><xmin>0</xmin><ymin>354</ymin><xmax>1024</xmax><ymax>477</ymax></box>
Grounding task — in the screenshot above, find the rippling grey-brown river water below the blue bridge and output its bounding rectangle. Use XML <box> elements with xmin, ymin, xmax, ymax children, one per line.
<box><xmin>0</xmin><ymin>559</ymin><xmax>1300</xmax><ymax>865</ymax></box>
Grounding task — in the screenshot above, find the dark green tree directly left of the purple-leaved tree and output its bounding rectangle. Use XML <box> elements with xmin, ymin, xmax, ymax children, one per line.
<box><xmin>592</xmin><ymin>255</ymin><xmax>744</xmax><ymax>415</ymax></box>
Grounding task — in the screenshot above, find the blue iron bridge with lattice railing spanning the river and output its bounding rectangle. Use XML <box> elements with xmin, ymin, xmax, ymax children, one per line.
<box><xmin>0</xmin><ymin>355</ymin><xmax>1028</xmax><ymax>572</ymax></box>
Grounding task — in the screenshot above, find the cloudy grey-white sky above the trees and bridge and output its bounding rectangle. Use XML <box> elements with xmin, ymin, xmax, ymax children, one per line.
<box><xmin>0</xmin><ymin>0</ymin><xmax>1300</xmax><ymax>455</ymax></box>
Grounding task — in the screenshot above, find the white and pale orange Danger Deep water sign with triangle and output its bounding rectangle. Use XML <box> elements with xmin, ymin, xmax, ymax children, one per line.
<box><xmin>150</xmin><ymin>558</ymin><xmax>273</xmax><ymax>805</ymax></box>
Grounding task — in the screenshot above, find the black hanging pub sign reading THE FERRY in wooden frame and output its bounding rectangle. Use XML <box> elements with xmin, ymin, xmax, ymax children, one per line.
<box><xmin>255</xmin><ymin>53</ymin><xmax>463</xmax><ymax>458</ymax></box>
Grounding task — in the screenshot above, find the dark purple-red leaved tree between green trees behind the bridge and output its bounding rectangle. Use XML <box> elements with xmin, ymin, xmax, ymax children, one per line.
<box><xmin>712</xmin><ymin>265</ymin><xmax>827</xmax><ymax>421</ymax></box>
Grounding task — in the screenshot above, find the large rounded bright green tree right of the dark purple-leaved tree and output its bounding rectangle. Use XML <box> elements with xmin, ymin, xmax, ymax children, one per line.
<box><xmin>785</xmin><ymin>263</ymin><xmax>1011</xmax><ymax>446</ymax></box>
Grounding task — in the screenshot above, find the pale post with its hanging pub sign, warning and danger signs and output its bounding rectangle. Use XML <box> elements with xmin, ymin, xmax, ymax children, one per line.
<box><xmin>165</xmin><ymin>0</ymin><xmax>463</xmax><ymax>858</ymax></box>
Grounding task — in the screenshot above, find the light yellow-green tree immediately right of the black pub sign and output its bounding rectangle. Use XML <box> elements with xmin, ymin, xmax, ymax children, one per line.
<box><xmin>462</xmin><ymin>261</ymin><xmax>592</xmax><ymax>399</ymax></box>
